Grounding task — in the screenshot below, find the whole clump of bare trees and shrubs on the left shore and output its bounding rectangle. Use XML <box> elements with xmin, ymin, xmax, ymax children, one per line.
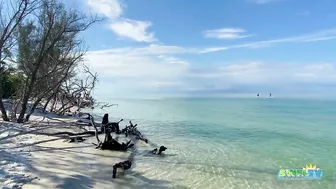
<box><xmin>0</xmin><ymin>0</ymin><xmax>100</xmax><ymax>123</ymax></box>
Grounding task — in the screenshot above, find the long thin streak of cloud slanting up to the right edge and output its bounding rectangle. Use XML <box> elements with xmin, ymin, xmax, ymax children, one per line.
<box><xmin>199</xmin><ymin>29</ymin><xmax>336</xmax><ymax>53</ymax></box>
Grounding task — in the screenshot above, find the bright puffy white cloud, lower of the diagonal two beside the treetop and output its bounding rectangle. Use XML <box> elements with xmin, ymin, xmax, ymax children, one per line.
<box><xmin>110</xmin><ymin>19</ymin><xmax>157</xmax><ymax>42</ymax></box>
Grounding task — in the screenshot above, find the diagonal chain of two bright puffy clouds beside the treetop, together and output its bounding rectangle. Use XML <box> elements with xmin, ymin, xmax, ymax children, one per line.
<box><xmin>87</xmin><ymin>0</ymin><xmax>157</xmax><ymax>43</ymax></box>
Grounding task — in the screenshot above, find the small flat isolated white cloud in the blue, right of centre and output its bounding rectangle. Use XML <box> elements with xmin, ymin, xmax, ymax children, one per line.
<box><xmin>204</xmin><ymin>28</ymin><xmax>250</xmax><ymax>39</ymax></box>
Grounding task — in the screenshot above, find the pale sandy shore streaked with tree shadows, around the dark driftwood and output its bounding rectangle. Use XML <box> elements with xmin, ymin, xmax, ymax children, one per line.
<box><xmin>0</xmin><ymin>113</ymin><xmax>170</xmax><ymax>189</ymax></box>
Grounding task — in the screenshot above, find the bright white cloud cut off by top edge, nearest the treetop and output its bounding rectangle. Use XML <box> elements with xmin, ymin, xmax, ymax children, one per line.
<box><xmin>87</xmin><ymin>0</ymin><xmax>123</xmax><ymax>19</ymax></box>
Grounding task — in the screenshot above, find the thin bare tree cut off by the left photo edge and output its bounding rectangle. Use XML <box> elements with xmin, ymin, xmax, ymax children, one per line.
<box><xmin>0</xmin><ymin>0</ymin><xmax>38</xmax><ymax>121</ymax></box>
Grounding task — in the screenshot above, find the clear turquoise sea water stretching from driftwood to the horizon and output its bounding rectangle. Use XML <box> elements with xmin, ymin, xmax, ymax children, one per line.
<box><xmin>90</xmin><ymin>98</ymin><xmax>336</xmax><ymax>189</ymax></box>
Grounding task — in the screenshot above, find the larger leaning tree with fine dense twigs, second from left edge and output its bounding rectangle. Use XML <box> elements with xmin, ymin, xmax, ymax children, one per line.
<box><xmin>17</xmin><ymin>0</ymin><xmax>98</xmax><ymax>123</ymax></box>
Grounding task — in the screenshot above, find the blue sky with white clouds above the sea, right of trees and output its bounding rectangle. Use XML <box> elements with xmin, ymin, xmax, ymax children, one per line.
<box><xmin>67</xmin><ymin>0</ymin><xmax>336</xmax><ymax>98</ymax></box>
